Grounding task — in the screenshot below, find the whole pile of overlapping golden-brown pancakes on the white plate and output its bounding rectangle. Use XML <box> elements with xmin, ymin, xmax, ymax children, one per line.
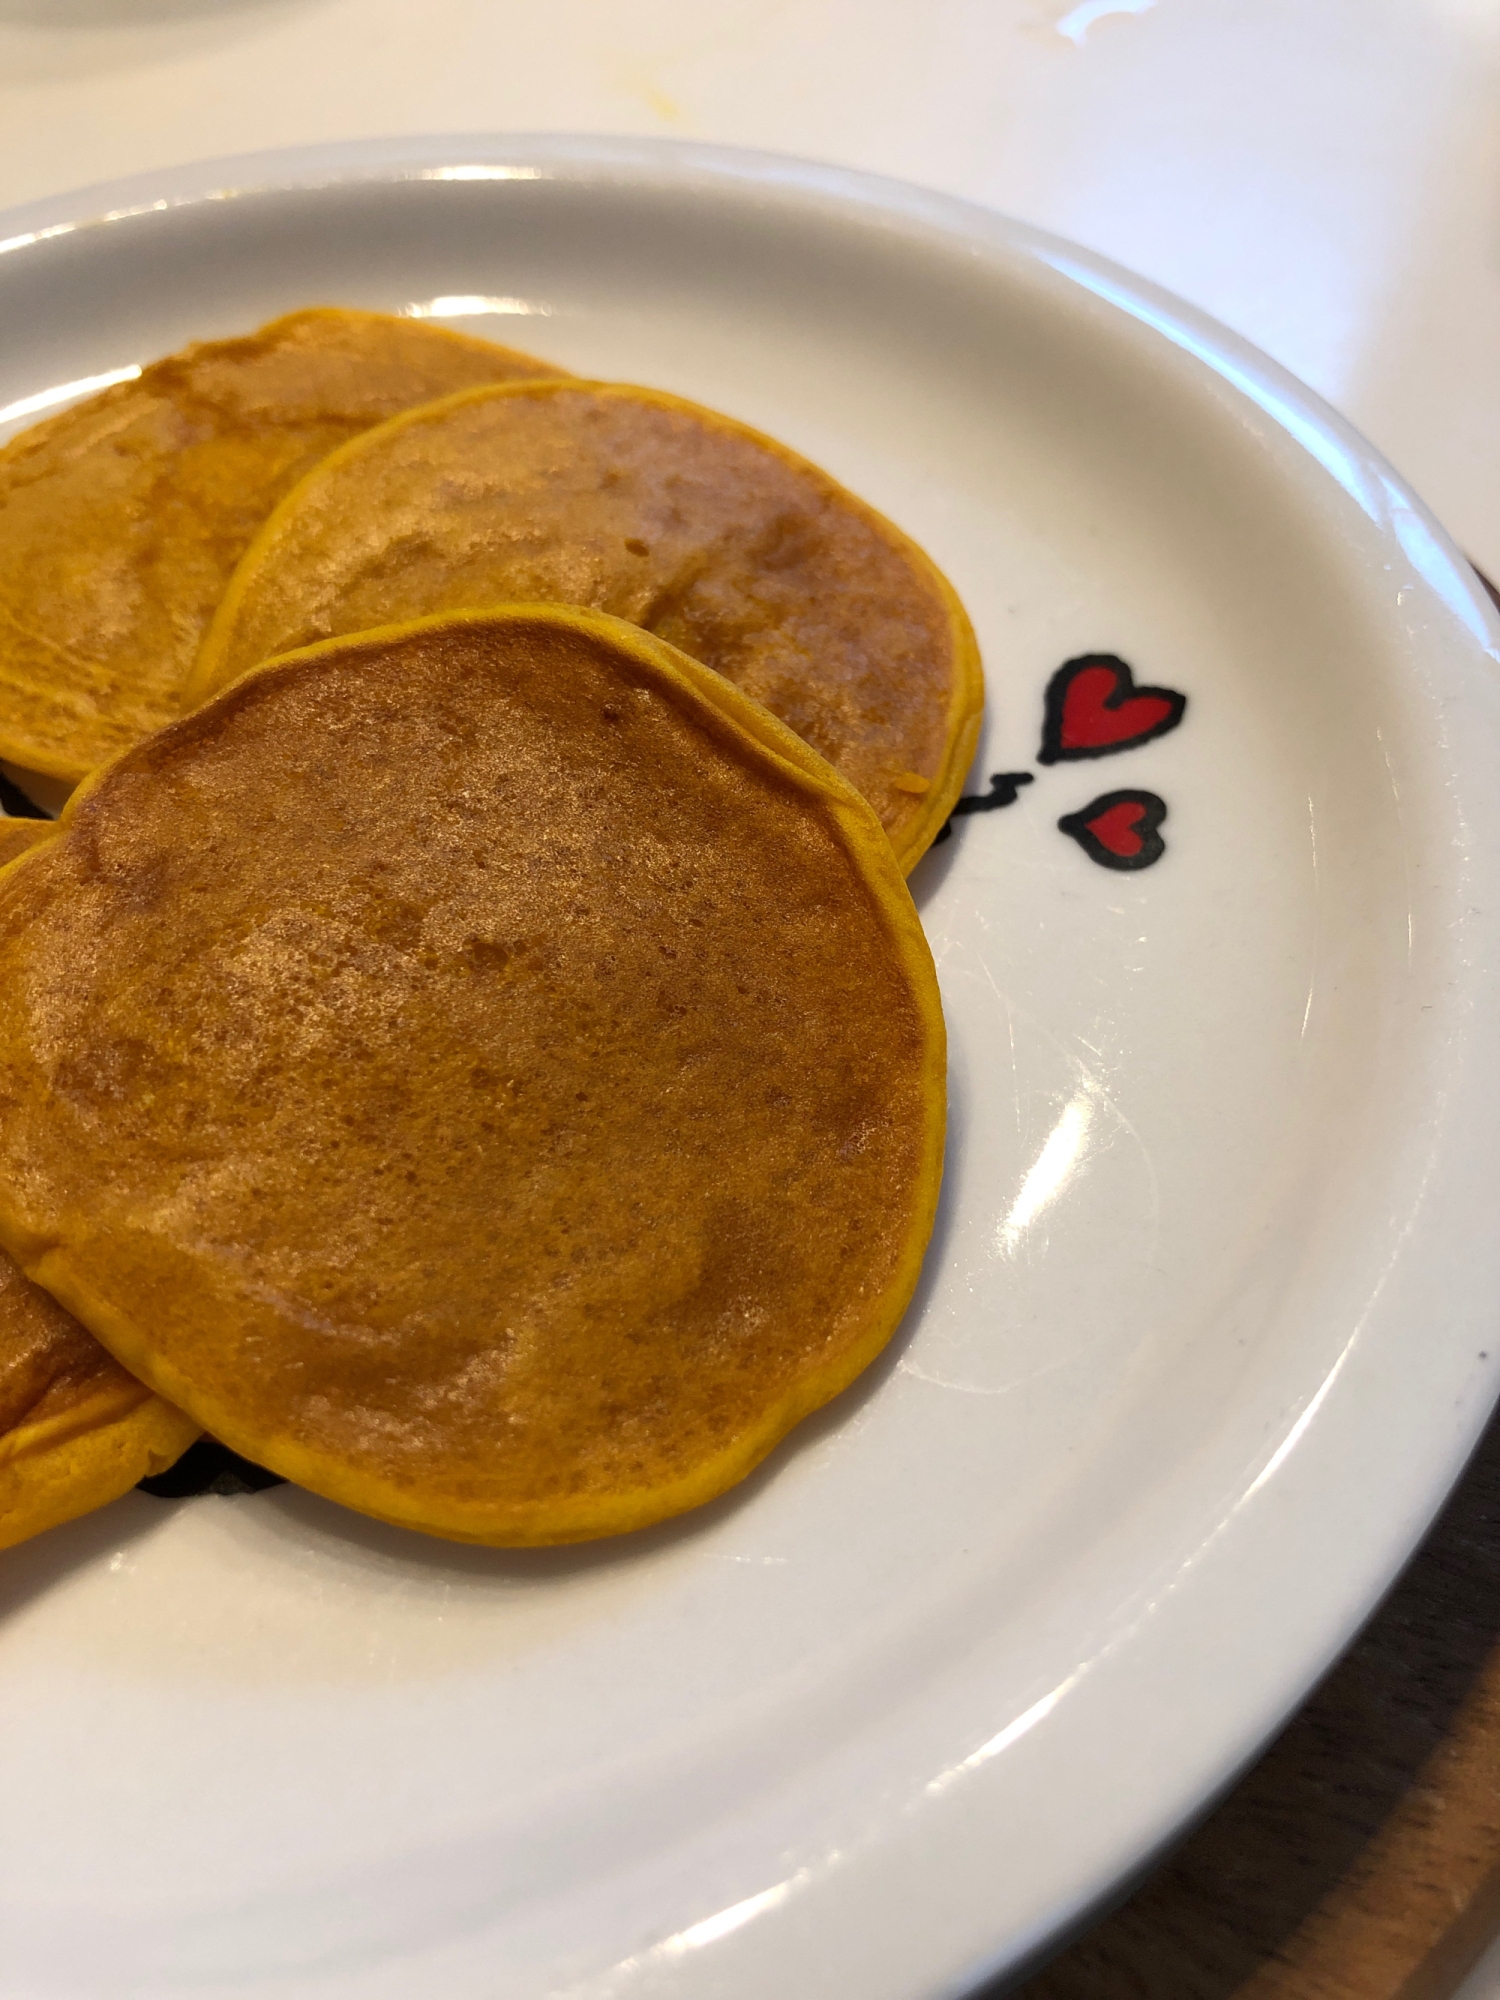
<box><xmin>0</xmin><ymin>310</ymin><xmax>982</xmax><ymax>1546</ymax></box>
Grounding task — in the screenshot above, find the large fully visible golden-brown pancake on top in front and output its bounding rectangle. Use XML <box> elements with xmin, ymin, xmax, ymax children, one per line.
<box><xmin>0</xmin><ymin>608</ymin><xmax>944</xmax><ymax>1544</ymax></box>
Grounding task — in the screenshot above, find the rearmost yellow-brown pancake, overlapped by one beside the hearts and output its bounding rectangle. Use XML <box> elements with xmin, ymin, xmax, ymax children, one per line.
<box><xmin>0</xmin><ymin>308</ymin><xmax>556</xmax><ymax>780</ymax></box>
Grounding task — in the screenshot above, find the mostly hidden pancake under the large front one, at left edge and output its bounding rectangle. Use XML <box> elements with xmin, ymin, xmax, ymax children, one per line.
<box><xmin>0</xmin><ymin>818</ymin><xmax>198</xmax><ymax>1548</ymax></box>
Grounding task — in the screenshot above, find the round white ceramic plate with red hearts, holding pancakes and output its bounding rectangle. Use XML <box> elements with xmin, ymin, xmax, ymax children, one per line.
<box><xmin>0</xmin><ymin>138</ymin><xmax>1500</xmax><ymax>2000</ymax></box>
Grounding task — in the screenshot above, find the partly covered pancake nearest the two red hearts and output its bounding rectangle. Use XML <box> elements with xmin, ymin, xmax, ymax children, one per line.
<box><xmin>188</xmin><ymin>380</ymin><xmax>984</xmax><ymax>868</ymax></box>
